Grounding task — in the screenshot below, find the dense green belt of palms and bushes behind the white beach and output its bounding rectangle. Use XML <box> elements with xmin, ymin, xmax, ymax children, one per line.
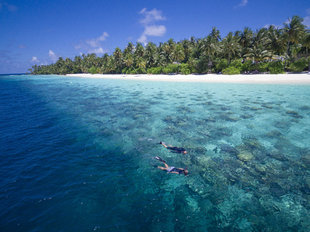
<box><xmin>30</xmin><ymin>16</ymin><xmax>310</xmax><ymax>74</ymax></box>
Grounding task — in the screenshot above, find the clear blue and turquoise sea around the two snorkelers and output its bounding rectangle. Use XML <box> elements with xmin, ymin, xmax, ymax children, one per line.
<box><xmin>0</xmin><ymin>75</ymin><xmax>310</xmax><ymax>232</ymax></box>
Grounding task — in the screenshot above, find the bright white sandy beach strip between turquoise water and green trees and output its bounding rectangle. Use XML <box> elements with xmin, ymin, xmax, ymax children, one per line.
<box><xmin>66</xmin><ymin>73</ymin><xmax>310</xmax><ymax>85</ymax></box>
